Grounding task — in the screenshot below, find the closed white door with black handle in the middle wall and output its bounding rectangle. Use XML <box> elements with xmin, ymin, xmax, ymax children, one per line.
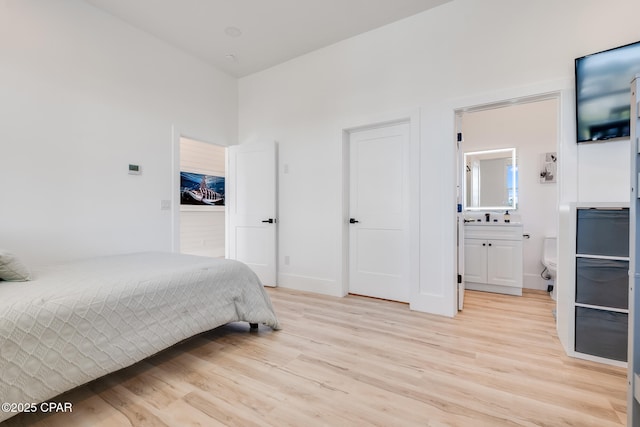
<box><xmin>349</xmin><ymin>123</ymin><xmax>410</xmax><ymax>302</ymax></box>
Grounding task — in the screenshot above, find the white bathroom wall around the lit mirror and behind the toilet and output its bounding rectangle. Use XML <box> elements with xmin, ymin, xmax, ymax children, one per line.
<box><xmin>462</xmin><ymin>99</ymin><xmax>558</xmax><ymax>289</ymax></box>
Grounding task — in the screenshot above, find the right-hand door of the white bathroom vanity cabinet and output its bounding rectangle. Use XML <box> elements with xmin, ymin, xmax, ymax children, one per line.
<box><xmin>487</xmin><ymin>240</ymin><xmax>522</xmax><ymax>287</ymax></box>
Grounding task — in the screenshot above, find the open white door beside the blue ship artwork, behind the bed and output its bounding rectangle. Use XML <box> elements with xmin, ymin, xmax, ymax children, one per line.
<box><xmin>226</xmin><ymin>141</ymin><xmax>277</xmax><ymax>286</ymax></box>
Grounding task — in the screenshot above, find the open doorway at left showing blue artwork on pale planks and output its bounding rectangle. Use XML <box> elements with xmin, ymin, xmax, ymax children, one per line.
<box><xmin>179</xmin><ymin>137</ymin><xmax>226</xmax><ymax>258</ymax></box>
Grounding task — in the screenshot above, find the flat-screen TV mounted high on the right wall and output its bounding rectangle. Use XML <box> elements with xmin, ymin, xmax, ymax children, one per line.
<box><xmin>575</xmin><ymin>42</ymin><xmax>640</xmax><ymax>142</ymax></box>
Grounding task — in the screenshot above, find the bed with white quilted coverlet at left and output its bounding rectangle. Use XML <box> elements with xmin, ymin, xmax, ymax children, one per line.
<box><xmin>0</xmin><ymin>253</ymin><xmax>279</xmax><ymax>421</ymax></box>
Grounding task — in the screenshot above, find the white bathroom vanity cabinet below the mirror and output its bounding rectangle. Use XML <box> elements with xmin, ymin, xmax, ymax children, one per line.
<box><xmin>464</xmin><ymin>222</ymin><xmax>523</xmax><ymax>295</ymax></box>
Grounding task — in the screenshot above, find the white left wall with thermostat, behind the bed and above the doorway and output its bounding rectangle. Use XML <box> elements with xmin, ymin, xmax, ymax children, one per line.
<box><xmin>0</xmin><ymin>0</ymin><xmax>237</xmax><ymax>265</ymax></box>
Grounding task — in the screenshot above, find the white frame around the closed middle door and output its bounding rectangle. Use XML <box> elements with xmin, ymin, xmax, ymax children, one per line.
<box><xmin>338</xmin><ymin>108</ymin><xmax>420</xmax><ymax>304</ymax></box>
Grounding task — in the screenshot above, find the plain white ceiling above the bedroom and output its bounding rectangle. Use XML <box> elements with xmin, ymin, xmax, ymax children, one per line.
<box><xmin>84</xmin><ymin>0</ymin><xmax>451</xmax><ymax>77</ymax></box>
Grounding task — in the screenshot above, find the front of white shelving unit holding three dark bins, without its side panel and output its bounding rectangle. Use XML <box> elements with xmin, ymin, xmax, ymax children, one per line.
<box><xmin>573</xmin><ymin>203</ymin><xmax>629</xmax><ymax>364</ymax></box>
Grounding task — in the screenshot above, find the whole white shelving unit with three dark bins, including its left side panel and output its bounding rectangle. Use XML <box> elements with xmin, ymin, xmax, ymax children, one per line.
<box><xmin>557</xmin><ymin>202</ymin><xmax>630</xmax><ymax>367</ymax></box>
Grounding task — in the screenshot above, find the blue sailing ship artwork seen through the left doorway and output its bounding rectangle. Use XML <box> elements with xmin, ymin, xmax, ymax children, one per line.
<box><xmin>180</xmin><ymin>172</ymin><xmax>224</xmax><ymax>206</ymax></box>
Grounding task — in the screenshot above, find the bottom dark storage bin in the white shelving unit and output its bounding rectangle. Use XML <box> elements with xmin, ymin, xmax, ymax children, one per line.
<box><xmin>575</xmin><ymin>307</ymin><xmax>628</xmax><ymax>362</ymax></box>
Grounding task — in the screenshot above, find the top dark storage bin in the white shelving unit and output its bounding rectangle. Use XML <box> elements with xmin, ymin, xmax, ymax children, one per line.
<box><xmin>576</xmin><ymin>209</ymin><xmax>629</xmax><ymax>257</ymax></box>
